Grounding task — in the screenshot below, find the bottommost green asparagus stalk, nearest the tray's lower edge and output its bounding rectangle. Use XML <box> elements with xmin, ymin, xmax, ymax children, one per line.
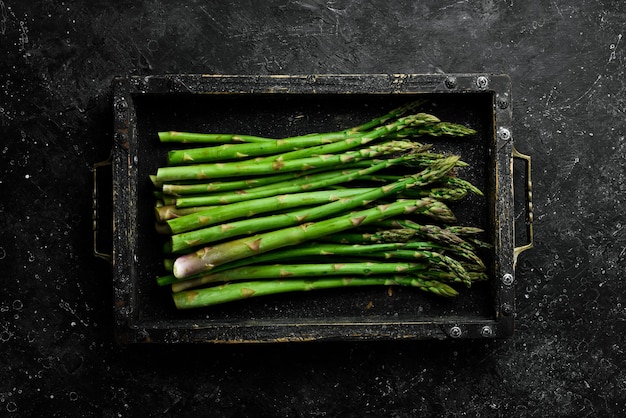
<box><xmin>172</xmin><ymin>276</ymin><xmax>458</xmax><ymax>309</ymax></box>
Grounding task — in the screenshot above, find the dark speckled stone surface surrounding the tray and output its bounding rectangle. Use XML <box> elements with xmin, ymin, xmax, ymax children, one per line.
<box><xmin>0</xmin><ymin>0</ymin><xmax>626</xmax><ymax>417</ymax></box>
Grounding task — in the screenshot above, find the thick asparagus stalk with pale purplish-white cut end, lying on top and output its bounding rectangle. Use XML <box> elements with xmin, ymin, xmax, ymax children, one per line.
<box><xmin>173</xmin><ymin>198</ymin><xmax>448</xmax><ymax>279</ymax></box>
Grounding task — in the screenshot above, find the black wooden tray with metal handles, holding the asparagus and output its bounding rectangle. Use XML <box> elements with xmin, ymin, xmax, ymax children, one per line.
<box><xmin>94</xmin><ymin>74</ymin><xmax>532</xmax><ymax>343</ymax></box>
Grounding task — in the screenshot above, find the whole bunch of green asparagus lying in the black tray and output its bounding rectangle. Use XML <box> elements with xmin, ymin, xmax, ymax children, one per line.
<box><xmin>151</xmin><ymin>101</ymin><xmax>488</xmax><ymax>309</ymax></box>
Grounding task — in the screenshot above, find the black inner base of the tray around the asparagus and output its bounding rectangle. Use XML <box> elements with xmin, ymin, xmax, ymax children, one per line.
<box><xmin>129</xmin><ymin>92</ymin><xmax>497</xmax><ymax>327</ymax></box>
